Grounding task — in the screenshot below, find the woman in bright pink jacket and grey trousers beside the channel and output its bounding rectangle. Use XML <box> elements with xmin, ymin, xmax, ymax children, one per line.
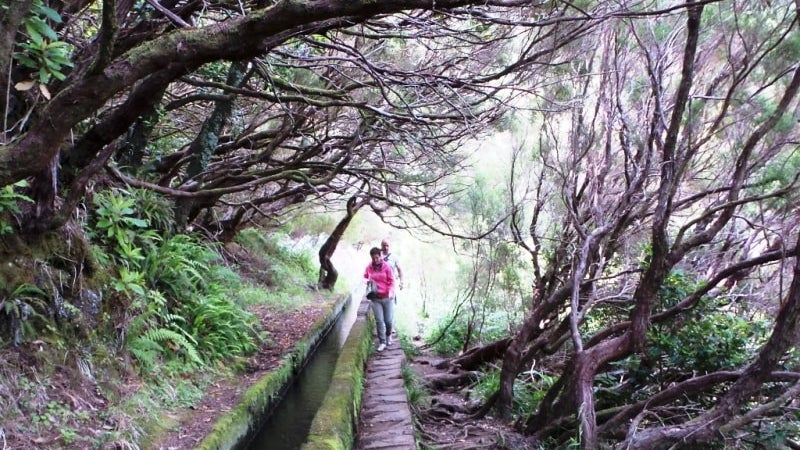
<box><xmin>364</xmin><ymin>247</ymin><xmax>394</xmax><ymax>352</ymax></box>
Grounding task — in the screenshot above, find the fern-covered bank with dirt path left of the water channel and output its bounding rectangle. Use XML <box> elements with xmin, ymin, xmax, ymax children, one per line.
<box><xmin>0</xmin><ymin>221</ymin><xmax>346</xmax><ymax>450</ymax></box>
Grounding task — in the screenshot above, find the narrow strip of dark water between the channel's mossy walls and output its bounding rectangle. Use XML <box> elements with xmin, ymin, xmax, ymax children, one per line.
<box><xmin>246</xmin><ymin>295</ymin><xmax>358</xmax><ymax>450</ymax></box>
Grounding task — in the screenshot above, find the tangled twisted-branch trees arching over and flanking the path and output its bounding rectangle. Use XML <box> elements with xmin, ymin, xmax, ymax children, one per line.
<box><xmin>0</xmin><ymin>0</ymin><xmax>800</xmax><ymax>449</ymax></box>
